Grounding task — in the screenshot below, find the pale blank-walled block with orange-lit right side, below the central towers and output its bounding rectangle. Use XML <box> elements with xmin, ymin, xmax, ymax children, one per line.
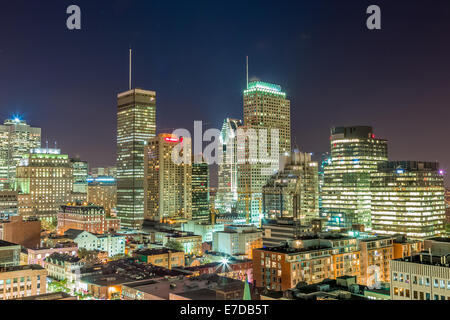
<box><xmin>213</xmin><ymin>225</ymin><xmax>262</xmax><ymax>259</ymax></box>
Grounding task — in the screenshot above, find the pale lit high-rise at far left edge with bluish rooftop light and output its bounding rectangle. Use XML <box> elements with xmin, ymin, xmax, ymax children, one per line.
<box><xmin>0</xmin><ymin>117</ymin><xmax>41</xmax><ymax>191</ymax></box>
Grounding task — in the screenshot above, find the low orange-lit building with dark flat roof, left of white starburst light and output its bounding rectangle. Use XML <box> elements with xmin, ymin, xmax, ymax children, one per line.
<box><xmin>133</xmin><ymin>248</ymin><xmax>184</xmax><ymax>269</ymax></box>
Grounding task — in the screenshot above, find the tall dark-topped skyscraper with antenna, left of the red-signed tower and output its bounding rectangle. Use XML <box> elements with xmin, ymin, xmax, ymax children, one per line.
<box><xmin>117</xmin><ymin>89</ymin><xmax>156</xmax><ymax>229</ymax></box>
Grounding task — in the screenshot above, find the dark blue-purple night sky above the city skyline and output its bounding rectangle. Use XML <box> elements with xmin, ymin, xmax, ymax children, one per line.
<box><xmin>0</xmin><ymin>0</ymin><xmax>450</xmax><ymax>185</ymax></box>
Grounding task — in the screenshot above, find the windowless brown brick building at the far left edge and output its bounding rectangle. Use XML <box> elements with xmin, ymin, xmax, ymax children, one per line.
<box><xmin>0</xmin><ymin>216</ymin><xmax>41</xmax><ymax>248</ymax></box>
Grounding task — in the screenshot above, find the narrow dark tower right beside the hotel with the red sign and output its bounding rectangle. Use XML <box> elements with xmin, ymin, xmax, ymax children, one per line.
<box><xmin>192</xmin><ymin>158</ymin><xmax>210</xmax><ymax>221</ymax></box>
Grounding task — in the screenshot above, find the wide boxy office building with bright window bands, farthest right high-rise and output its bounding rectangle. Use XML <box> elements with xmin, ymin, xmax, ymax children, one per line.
<box><xmin>371</xmin><ymin>161</ymin><xmax>445</xmax><ymax>238</ymax></box>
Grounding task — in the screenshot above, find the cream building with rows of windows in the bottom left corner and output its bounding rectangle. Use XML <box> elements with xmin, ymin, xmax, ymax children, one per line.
<box><xmin>0</xmin><ymin>265</ymin><xmax>47</xmax><ymax>300</ymax></box>
